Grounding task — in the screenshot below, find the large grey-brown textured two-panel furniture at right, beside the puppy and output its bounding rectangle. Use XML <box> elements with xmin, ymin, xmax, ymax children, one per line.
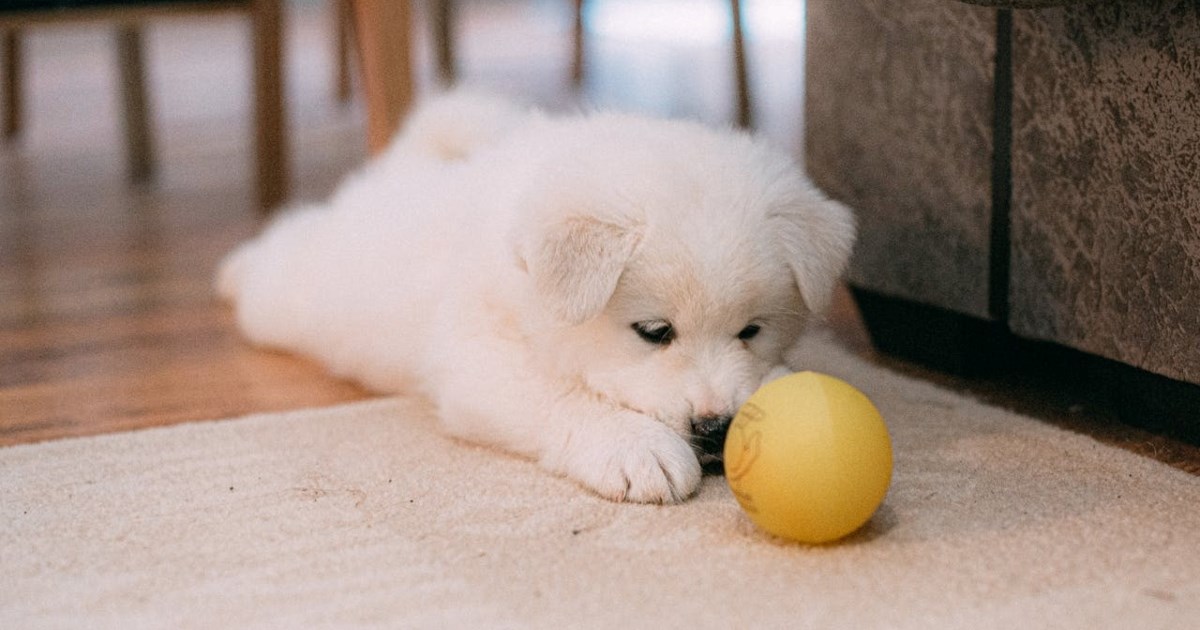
<box><xmin>805</xmin><ymin>0</ymin><xmax>1200</xmax><ymax>439</ymax></box>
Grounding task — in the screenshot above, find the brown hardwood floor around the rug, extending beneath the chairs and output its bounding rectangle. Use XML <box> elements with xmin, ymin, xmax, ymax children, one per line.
<box><xmin>0</xmin><ymin>0</ymin><xmax>1200</xmax><ymax>472</ymax></box>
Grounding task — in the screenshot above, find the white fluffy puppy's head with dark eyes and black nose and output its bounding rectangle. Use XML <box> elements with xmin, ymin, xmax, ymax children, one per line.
<box><xmin>517</xmin><ymin>116</ymin><xmax>854</xmax><ymax>460</ymax></box>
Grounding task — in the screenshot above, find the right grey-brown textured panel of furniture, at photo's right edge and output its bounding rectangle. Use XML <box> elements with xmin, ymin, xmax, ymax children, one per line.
<box><xmin>1010</xmin><ymin>0</ymin><xmax>1200</xmax><ymax>383</ymax></box>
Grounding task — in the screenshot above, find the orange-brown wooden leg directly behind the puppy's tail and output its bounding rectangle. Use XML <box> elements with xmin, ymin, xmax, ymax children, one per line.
<box><xmin>354</xmin><ymin>0</ymin><xmax>415</xmax><ymax>154</ymax></box>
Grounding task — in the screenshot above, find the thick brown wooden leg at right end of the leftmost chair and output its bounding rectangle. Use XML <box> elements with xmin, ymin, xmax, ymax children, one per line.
<box><xmin>251</xmin><ymin>0</ymin><xmax>285</xmax><ymax>211</ymax></box>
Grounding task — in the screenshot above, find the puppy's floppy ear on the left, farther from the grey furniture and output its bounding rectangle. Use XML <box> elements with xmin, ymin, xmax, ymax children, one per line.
<box><xmin>522</xmin><ymin>216</ymin><xmax>641</xmax><ymax>324</ymax></box>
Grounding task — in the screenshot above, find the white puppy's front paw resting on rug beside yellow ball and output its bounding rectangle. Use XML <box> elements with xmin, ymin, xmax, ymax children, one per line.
<box><xmin>542</xmin><ymin>413</ymin><xmax>701</xmax><ymax>503</ymax></box>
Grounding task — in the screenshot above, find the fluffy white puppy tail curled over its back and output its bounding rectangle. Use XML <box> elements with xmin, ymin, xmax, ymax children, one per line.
<box><xmin>392</xmin><ymin>89</ymin><xmax>527</xmax><ymax>162</ymax></box>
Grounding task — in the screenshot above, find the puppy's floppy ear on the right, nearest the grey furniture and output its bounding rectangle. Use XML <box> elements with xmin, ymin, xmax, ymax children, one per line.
<box><xmin>770</xmin><ymin>193</ymin><xmax>856</xmax><ymax>313</ymax></box>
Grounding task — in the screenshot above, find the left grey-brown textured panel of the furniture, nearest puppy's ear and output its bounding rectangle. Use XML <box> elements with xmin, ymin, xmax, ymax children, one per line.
<box><xmin>805</xmin><ymin>0</ymin><xmax>996</xmax><ymax>317</ymax></box>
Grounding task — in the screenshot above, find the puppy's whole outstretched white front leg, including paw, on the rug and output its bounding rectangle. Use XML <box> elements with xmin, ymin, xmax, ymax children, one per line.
<box><xmin>437</xmin><ymin>355</ymin><xmax>701</xmax><ymax>503</ymax></box>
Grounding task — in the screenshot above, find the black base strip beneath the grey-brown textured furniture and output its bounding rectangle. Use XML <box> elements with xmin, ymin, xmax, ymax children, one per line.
<box><xmin>851</xmin><ymin>287</ymin><xmax>1200</xmax><ymax>446</ymax></box>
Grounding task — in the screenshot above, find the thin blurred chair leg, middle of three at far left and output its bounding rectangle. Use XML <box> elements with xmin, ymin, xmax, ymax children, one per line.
<box><xmin>116</xmin><ymin>25</ymin><xmax>154</xmax><ymax>181</ymax></box>
